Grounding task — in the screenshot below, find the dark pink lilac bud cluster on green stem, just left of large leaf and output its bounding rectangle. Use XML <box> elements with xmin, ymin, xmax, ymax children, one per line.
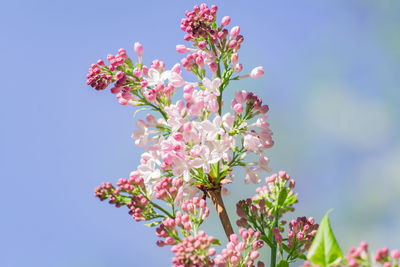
<box><xmin>236</xmin><ymin>171</ymin><xmax>318</xmax><ymax>262</ymax></box>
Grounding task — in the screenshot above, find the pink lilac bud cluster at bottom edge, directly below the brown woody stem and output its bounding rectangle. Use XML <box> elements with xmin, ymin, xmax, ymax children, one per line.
<box><xmin>214</xmin><ymin>228</ymin><xmax>264</xmax><ymax>267</ymax></box>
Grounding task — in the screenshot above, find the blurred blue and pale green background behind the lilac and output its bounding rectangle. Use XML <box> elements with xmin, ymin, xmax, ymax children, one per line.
<box><xmin>0</xmin><ymin>0</ymin><xmax>400</xmax><ymax>267</ymax></box>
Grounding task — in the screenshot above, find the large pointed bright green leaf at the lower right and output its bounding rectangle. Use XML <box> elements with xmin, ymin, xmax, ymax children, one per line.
<box><xmin>307</xmin><ymin>210</ymin><xmax>343</xmax><ymax>267</ymax></box>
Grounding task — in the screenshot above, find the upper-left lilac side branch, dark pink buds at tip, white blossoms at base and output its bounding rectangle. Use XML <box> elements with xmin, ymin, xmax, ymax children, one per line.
<box><xmin>87</xmin><ymin>43</ymin><xmax>185</xmax><ymax>107</ymax></box>
